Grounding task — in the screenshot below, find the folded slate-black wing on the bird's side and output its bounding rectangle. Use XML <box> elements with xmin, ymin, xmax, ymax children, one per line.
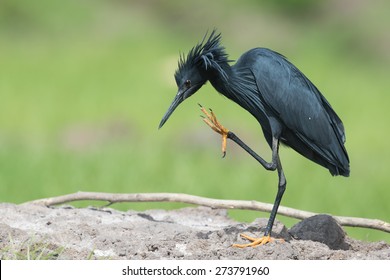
<box><xmin>252</xmin><ymin>50</ymin><xmax>345</xmax><ymax>149</ymax></box>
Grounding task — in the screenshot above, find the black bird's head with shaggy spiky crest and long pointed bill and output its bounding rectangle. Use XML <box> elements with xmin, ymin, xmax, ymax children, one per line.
<box><xmin>159</xmin><ymin>30</ymin><xmax>229</xmax><ymax>128</ymax></box>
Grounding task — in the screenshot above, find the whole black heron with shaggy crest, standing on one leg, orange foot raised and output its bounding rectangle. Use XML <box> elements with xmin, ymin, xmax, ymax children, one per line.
<box><xmin>159</xmin><ymin>29</ymin><xmax>350</xmax><ymax>248</ymax></box>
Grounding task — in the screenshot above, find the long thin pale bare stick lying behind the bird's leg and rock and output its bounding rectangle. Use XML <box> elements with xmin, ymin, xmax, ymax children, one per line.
<box><xmin>26</xmin><ymin>192</ymin><xmax>390</xmax><ymax>233</ymax></box>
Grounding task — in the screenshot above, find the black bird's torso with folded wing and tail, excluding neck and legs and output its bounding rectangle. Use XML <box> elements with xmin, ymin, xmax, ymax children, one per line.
<box><xmin>233</xmin><ymin>48</ymin><xmax>349</xmax><ymax>176</ymax></box>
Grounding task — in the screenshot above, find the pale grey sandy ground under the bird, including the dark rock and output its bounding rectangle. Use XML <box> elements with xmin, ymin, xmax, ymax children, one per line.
<box><xmin>0</xmin><ymin>203</ymin><xmax>390</xmax><ymax>259</ymax></box>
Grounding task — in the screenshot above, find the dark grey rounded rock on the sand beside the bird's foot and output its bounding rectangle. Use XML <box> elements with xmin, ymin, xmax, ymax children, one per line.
<box><xmin>289</xmin><ymin>214</ymin><xmax>348</xmax><ymax>250</ymax></box>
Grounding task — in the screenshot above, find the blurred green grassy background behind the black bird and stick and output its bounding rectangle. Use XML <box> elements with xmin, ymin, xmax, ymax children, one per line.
<box><xmin>0</xmin><ymin>0</ymin><xmax>390</xmax><ymax>242</ymax></box>
